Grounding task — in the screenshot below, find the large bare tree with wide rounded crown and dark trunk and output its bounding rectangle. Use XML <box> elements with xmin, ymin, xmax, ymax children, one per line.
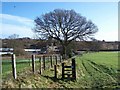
<box><xmin>34</xmin><ymin>9</ymin><xmax>98</xmax><ymax>57</ymax></box>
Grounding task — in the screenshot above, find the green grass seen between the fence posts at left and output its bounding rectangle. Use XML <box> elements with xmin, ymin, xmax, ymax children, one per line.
<box><xmin>2</xmin><ymin>58</ymin><xmax>55</xmax><ymax>78</ymax></box>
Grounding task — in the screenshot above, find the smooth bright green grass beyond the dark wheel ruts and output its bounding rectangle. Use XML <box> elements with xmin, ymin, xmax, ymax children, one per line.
<box><xmin>79</xmin><ymin>52</ymin><xmax>118</xmax><ymax>69</ymax></box>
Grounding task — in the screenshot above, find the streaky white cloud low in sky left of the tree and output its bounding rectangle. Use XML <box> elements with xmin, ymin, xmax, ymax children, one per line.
<box><xmin>0</xmin><ymin>14</ymin><xmax>34</xmax><ymax>38</ymax></box>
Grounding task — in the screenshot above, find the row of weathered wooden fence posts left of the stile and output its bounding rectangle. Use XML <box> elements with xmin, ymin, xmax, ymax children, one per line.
<box><xmin>12</xmin><ymin>54</ymin><xmax>62</xmax><ymax>79</ymax></box>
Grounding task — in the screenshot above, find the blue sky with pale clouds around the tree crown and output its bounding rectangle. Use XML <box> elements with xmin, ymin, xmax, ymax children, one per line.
<box><xmin>0</xmin><ymin>2</ymin><xmax>118</xmax><ymax>41</ymax></box>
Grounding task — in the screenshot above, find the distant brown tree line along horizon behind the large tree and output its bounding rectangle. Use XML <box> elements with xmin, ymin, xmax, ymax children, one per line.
<box><xmin>2</xmin><ymin>34</ymin><xmax>119</xmax><ymax>55</ymax></box>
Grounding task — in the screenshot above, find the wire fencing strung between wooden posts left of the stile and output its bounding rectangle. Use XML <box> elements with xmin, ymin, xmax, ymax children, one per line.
<box><xmin>2</xmin><ymin>54</ymin><xmax>62</xmax><ymax>78</ymax></box>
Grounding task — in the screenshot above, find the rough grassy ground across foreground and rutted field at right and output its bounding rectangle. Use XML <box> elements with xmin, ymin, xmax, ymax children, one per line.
<box><xmin>3</xmin><ymin>52</ymin><xmax>119</xmax><ymax>88</ymax></box>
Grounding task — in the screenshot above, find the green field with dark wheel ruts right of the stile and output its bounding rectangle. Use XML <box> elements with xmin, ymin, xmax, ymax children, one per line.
<box><xmin>76</xmin><ymin>52</ymin><xmax>118</xmax><ymax>87</ymax></box>
